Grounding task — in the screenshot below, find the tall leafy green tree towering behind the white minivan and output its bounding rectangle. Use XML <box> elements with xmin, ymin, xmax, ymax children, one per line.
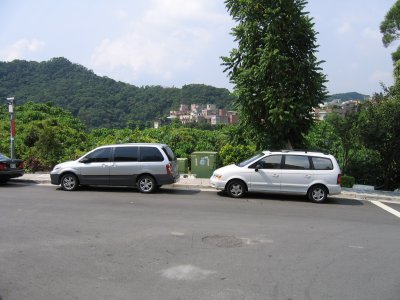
<box><xmin>222</xmin><ymin>0</ymin><xmax>326</xmax><ymax>148</ymax></box>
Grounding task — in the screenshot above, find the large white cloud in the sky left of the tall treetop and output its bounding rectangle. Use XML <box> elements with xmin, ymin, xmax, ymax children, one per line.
<box><xmin>91</xmin><ymin>0</ymin><xmax>231</xmax><ymax>81</ymax></box>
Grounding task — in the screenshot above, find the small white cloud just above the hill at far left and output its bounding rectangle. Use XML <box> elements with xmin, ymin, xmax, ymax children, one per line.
<box><xmin>0</xmin><ymin>39</ymin><xmax>45</xmax><ymax>61</ymax></box>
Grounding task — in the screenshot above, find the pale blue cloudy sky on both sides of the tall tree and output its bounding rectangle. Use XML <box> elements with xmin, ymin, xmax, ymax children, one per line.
<box><xmin>0</xmin><ymin>0</ymin><xmax>398</xmax><ymax>95</ymax></box>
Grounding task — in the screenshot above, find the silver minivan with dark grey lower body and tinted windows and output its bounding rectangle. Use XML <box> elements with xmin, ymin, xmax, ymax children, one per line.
<box><xmin>50</xmin><ymin>143</ymin><xmax>179</xmax><ymax>193</ymax></box>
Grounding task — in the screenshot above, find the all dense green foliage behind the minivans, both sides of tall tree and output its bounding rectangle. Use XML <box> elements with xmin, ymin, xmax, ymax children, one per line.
<box><xmin>0</xmin><ymin>101</ymin><xmax>400</xmax><ymax>189</ymax></box>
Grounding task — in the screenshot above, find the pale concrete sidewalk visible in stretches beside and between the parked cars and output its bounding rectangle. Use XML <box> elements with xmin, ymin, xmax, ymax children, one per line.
<box><xmin>12</xmin><ymin>173</ymin><xmax>400</xmax><ymax>203</ymax></box>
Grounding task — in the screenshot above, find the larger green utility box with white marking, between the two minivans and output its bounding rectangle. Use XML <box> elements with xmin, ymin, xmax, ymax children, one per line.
<box><xmin>190</xmin><ymin>151</ymin><xmax>218</xmax><ymax>178</ymax></box>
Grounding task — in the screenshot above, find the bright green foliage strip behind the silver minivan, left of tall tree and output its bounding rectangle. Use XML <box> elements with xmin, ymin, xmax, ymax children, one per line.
<box><xmin>0</xmin><ymin>102</ymin><xmax>254</xmax><ymax>171</ymax></box>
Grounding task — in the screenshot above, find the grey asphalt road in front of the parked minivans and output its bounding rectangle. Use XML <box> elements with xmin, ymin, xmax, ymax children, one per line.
<box><xmin>0</xmin><ymin>183</ymin><xmax>400</xmax><ymax>300</ymax></box>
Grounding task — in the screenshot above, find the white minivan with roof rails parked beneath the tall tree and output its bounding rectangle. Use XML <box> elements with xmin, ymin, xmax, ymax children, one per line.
<box><xmin>210</xmin><ymin>150</ymin><xmax>341</xmax><ymax>203</ymax></box>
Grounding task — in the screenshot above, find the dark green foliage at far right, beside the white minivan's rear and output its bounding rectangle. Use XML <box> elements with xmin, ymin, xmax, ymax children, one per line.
<box><xmin>305</xmin><ymin>89</ymin><xmax>400</xmax><ymax>190</ymax></box>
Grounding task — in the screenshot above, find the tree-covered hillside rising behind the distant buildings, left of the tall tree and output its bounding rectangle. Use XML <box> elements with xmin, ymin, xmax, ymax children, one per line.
<box><xmin>0</xmin><ymin>57</ymin><xmax>234</xmax><ymax>128</ymax></box>
